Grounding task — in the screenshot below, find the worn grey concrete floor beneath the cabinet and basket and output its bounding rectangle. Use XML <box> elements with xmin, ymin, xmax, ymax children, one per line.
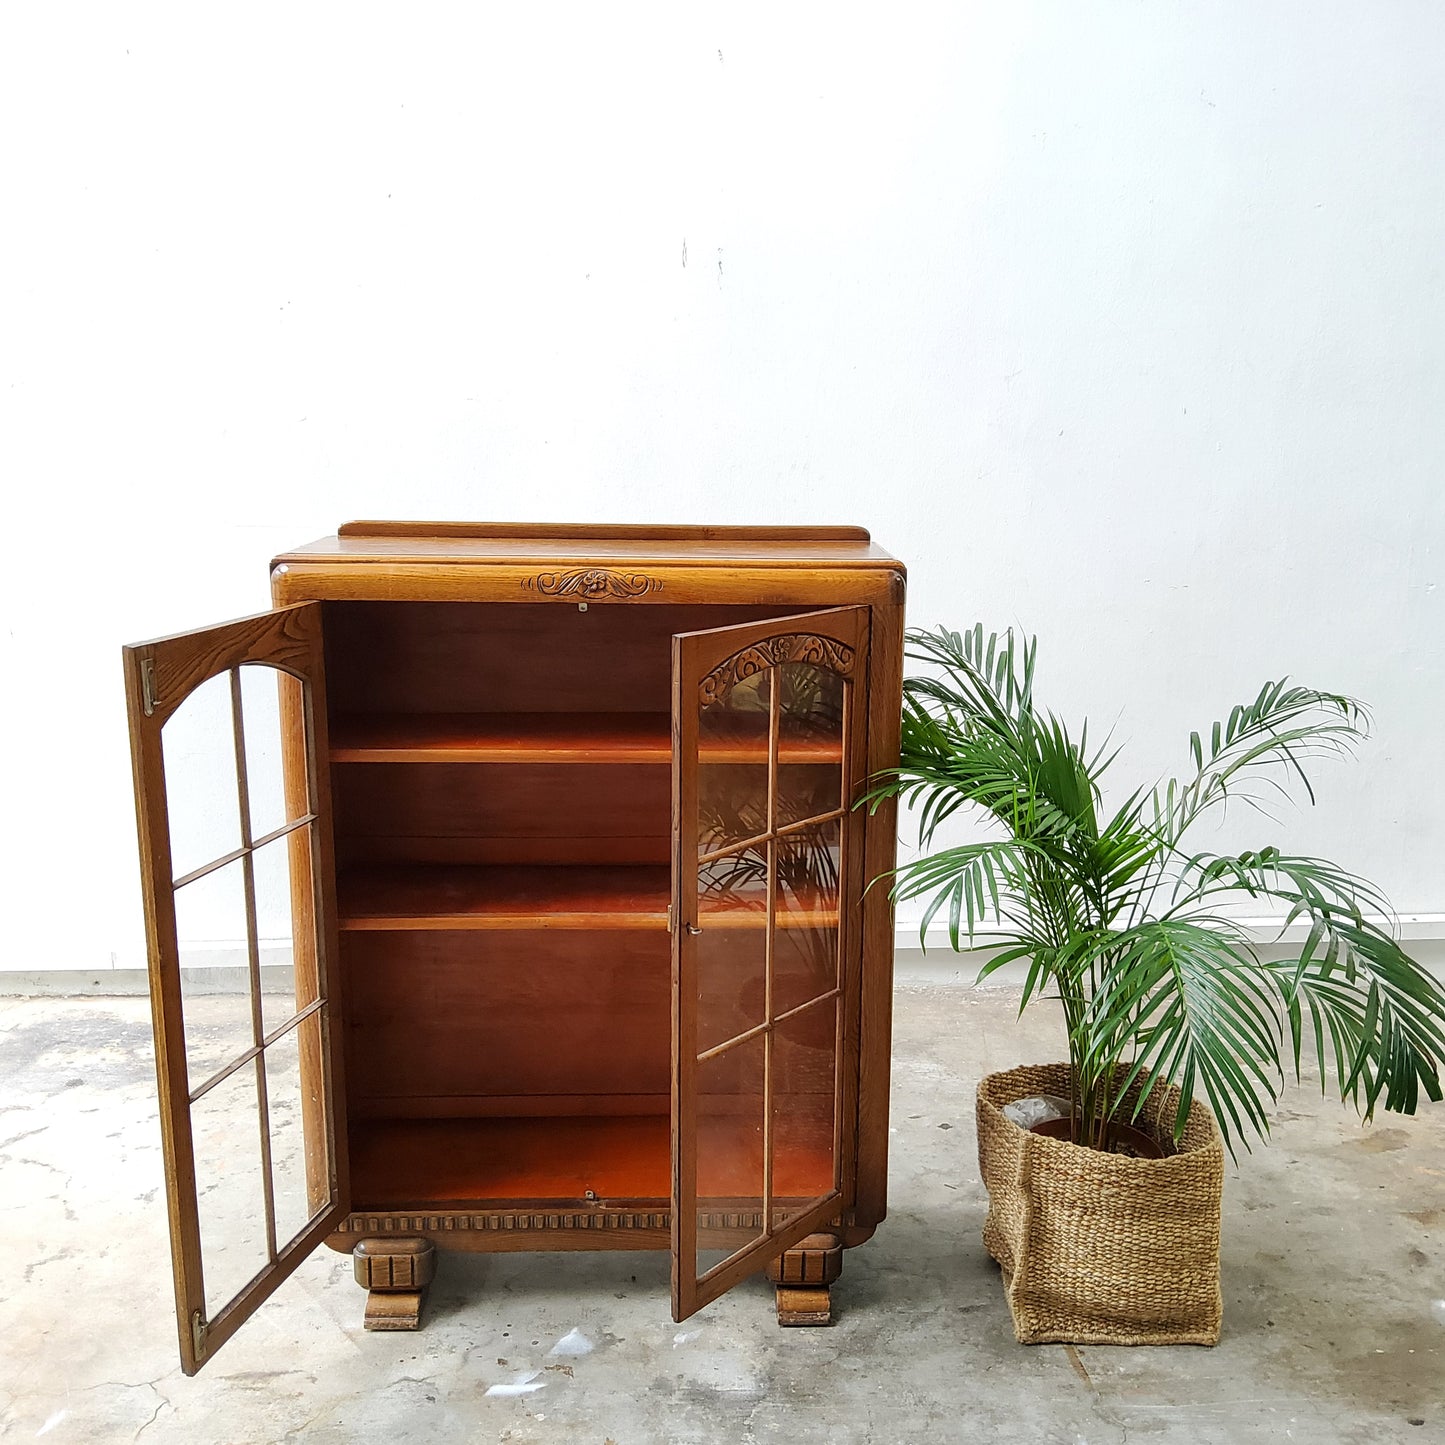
<box><xmin>0</xmin><ymin>984</ymin><xmax>1445</xmax><ymax>1445</ymax></box>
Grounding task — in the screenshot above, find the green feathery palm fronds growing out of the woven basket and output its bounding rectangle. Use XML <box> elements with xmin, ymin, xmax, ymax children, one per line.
<box><xmin>864</xmin><ymin>626</ymin><xmax>1445</xmax><ymax>1152</ymax></box>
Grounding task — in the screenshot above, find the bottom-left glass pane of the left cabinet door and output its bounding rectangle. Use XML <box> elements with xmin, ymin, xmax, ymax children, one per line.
<box><xmin>191</xmin><ymin>1062</ymin><xmax>270</xmax><ymax>1319</ymax></box>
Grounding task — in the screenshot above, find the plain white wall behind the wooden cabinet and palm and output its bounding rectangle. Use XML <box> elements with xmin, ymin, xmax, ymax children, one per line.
<box><xmin>0</xmin><ymin>0</ymin><xmax>1445</xmax><ymax>970</ymax></box>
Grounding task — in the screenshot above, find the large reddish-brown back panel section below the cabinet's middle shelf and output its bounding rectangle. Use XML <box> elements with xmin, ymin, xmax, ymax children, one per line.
<box><xmin>341</xmin><ymin>931</ymin><xmax>672</xmax><ymax>1117</ymax></box>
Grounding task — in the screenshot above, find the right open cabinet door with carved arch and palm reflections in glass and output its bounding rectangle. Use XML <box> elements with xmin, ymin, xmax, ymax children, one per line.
<box><xmin>672</xmin><ymin>607</ymin><xmax>868</xmax><ymax>1319</ymax></box>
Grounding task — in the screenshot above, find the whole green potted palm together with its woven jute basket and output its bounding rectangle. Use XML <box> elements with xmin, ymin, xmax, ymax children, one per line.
<box><xmin>870</xmin><ymin>627</ymin><xmax>1445</xmax><ymax>1344</ymax></box>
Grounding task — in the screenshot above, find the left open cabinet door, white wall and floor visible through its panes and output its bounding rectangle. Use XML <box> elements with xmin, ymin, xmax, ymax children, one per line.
<box><xmin>124</xmin><ymin>603</ymin><xmax>348</xmax><ymax>1374</ymax></box>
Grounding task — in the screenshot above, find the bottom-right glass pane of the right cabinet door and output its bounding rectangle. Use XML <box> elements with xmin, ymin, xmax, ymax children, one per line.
<box><xmin>773</xmin><ymin>998</ymin><xmax>838</xmax><ymax>1228</ymax></box>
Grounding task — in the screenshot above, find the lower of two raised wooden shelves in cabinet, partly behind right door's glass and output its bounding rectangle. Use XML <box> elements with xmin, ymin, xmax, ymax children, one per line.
<box><xmin>337</xmin><ymin>864</ymin><xmax>838</xmax><ymax>931</ymax></box>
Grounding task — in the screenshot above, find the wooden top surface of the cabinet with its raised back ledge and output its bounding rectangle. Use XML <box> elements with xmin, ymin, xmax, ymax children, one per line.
<box><xmin>276</xmin><ymin>522</ymin><xmax>902</xmax><ymax>571</ymax></box>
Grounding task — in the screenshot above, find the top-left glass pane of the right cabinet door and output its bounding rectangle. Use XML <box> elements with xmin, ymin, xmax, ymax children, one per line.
<box><xmin>698</xmin><ymin>670</ymin><xmax>772</xmax><ymax>854</ymax></box>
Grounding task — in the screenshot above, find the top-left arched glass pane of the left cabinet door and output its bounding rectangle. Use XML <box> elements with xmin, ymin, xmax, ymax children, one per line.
<box><xmin>160</xmin><ymin>672</ymin><xmax>241</xmax><ymax>879</ymax></box>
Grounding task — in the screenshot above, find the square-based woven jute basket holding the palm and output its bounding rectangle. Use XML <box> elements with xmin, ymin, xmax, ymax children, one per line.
<box><xmin>978</xmin><ymin>1064</ymin><xmax>1224</xmax><ymax>1345</ymax></box>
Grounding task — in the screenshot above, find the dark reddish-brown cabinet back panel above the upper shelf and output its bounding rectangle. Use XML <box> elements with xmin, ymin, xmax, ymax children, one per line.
<box><xmin>325</xmin><ymin>603</ymin><xmax>809</xmax><ymax>714</ymax></box>
